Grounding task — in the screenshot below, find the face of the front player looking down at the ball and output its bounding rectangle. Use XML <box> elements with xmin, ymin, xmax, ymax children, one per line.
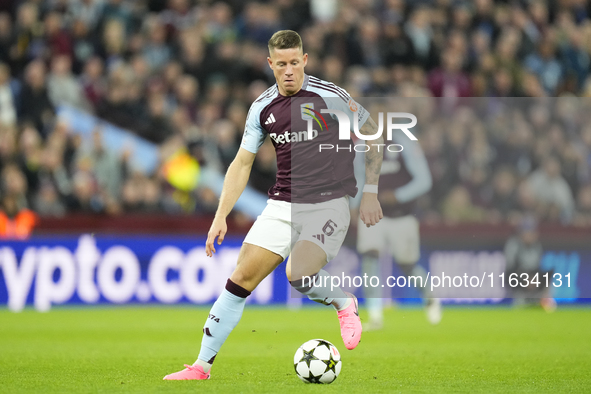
<box><xmin>267</xmin><ymin>48</ymin><xmax>308</xmax><ymax>96</ymax></box>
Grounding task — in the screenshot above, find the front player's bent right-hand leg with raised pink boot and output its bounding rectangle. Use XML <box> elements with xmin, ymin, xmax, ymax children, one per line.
<box><xmin>286</xmin><ymin>241</ymin><xmax>362</xmax><ymax>350</ymax></box>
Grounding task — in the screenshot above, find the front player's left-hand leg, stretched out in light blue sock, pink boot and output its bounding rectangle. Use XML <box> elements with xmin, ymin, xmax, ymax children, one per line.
<box><xmin>164</xmin><ymin>243</ymin><xmax>283</xmax><ymax>380</ymax></box>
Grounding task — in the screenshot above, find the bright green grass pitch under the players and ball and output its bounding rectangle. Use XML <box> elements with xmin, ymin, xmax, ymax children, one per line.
<box><xmin>0</xmin><ymin>306</ymin><xmax>591</xmax><ymax>394</ymax></box>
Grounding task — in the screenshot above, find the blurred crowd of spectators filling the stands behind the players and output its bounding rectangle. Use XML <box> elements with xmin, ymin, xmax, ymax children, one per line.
<box><xmin>0</xmin><ymin>0</ymin><xmax>591</xmax><ymax>232</ymax></box>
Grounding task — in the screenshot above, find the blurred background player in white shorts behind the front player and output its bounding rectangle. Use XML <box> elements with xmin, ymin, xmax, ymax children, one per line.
<box><xmin>357</xmin><ymin>130</ymin><xmax>441</xmax><ymax>329</ymax></box>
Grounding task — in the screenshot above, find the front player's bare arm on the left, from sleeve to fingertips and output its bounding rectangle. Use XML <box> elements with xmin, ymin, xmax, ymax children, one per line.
<box><xmin>205</xmin><ymin>148</ymin><xmax>255</xmax><ymax>257</ymax></box>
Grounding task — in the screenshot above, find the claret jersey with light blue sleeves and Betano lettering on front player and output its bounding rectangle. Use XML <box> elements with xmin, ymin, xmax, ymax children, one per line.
<box><xmin>241</xmin><ymin>75</ymin><xmax>369</xmax><ymax>203</ymax></box>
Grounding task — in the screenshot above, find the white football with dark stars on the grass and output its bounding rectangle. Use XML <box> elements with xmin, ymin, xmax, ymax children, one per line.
<box><xmin>293</xmin><ymin>339</ymin><xmax>342</xmax><ymax>384</ymax></box>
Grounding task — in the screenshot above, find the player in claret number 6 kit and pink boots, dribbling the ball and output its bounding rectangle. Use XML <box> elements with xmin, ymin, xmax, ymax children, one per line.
<box><xmin>164</xmin><ymin>30</ymin><xmax>383</xmax><ymax>380</ymax></box>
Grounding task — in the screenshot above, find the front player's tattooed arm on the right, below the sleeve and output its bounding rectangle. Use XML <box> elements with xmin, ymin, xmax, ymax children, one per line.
<box><xmin>359</xmin><ymin>117</ymin><xmax>384</xmax><ymax>227</ymax></box>
